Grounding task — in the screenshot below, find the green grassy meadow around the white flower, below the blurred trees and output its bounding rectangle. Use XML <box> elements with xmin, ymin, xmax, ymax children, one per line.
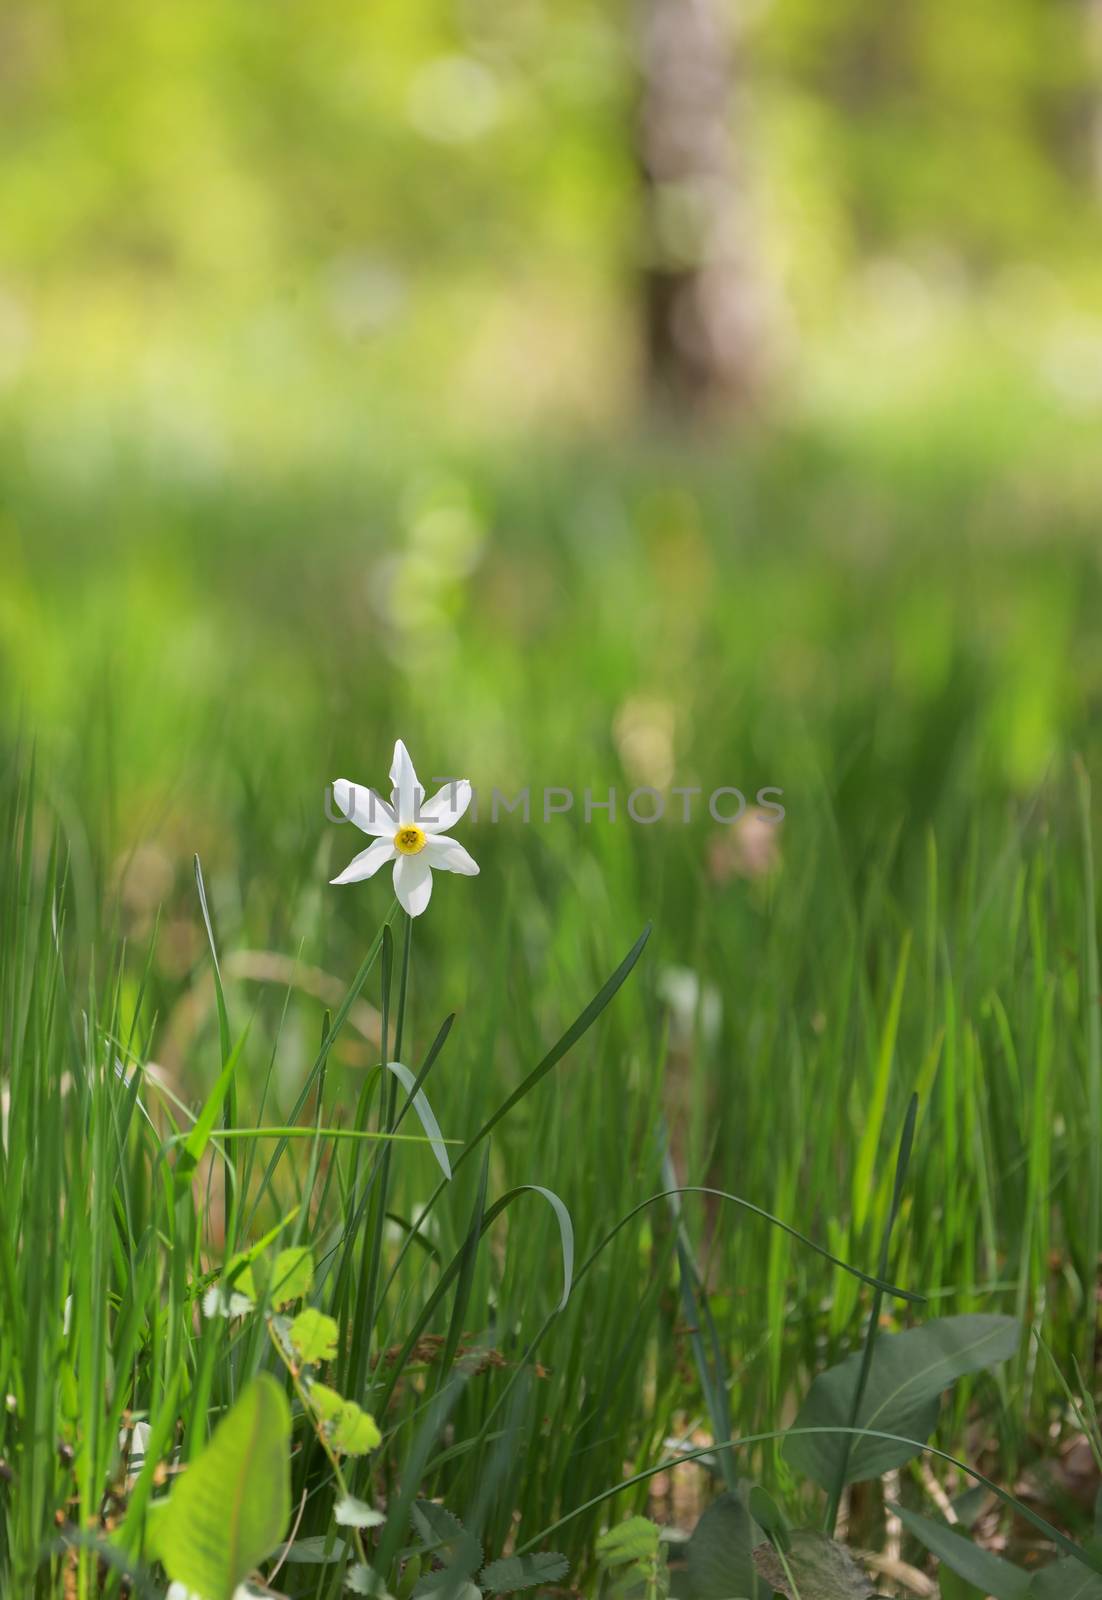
<box><xmin>0</xmin><ymin>396</ymin><xmax>1102</xmax><ymax>1595</ymax></box>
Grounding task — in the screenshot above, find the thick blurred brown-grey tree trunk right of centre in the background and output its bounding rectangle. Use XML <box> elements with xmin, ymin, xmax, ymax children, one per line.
<box><xmin>637</xmin><ymin>0</ymin><xmax>769</xmax><ymax>410</ymax></box>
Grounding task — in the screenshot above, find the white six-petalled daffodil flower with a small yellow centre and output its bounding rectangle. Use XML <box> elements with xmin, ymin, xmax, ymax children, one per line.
<box><xmin>329</xmin><ymin>739</ymin><xmax>478</xmax><ymax>917</ymax></box>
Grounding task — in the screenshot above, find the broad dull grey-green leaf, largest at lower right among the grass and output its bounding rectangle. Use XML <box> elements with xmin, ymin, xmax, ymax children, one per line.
<box><xmin>784</xmin><ymin>1317</ymin><xmax>1020</xmax><ymax>1490</ymax></box>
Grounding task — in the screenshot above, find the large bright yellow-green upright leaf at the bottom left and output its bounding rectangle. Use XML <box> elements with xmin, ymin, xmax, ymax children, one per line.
<box><xmin>155</xmin><ymin>1373</ymin><xmax>291</xmax><ymax>1600</ymax></box>
